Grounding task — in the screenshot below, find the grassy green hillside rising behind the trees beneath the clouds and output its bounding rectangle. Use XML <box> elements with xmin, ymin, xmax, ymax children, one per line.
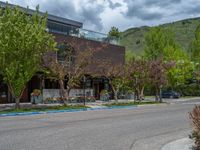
<box><xmin>120</xmin><ymin>18</ymin><xmax>200</xmax><ymax>55</ymax></box>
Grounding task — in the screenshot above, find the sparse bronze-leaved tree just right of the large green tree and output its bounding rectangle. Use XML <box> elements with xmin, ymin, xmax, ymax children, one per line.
<box><xmin>45</xmin><ymin>42</ymin><xmax>95</xmax><ymax>105</ymax></box>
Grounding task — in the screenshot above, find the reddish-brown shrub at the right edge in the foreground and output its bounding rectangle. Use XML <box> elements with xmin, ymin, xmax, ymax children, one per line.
<box><xmin>190</xmin><ymin>106</ymin><xmax>200</xmax><ymax>150</ymax></box>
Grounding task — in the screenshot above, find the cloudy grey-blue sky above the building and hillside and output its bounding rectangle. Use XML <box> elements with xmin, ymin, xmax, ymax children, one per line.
<box><xmin>3</xmin><ymin>0</ymin><xmax>200</xmax><ymax>33</ymax></box>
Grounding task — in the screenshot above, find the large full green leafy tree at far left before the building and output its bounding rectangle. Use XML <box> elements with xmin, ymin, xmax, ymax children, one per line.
<box><xmin>0</xmin><ymin>7</ymin><xmax>56</xmax><ymax>109</ymax></box>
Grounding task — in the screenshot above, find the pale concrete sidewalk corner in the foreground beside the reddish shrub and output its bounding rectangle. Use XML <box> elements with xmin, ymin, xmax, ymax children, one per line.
<box><xmin>161</xmin><ymin>138</ymin><xmax>193</xmax><ymax>150</ymax></box>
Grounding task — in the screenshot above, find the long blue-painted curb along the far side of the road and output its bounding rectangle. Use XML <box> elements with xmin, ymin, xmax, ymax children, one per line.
<box><xmin>0</xmin><ymin>106</ymin><xmax>137</xmax><ymax>117</ymax></box>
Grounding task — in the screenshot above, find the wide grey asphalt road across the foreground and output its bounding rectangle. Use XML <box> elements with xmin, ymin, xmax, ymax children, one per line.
<box><xmin>0</xmin><ymin>100</ymin><xmax>197</xmax><ymax>150</ymax></box>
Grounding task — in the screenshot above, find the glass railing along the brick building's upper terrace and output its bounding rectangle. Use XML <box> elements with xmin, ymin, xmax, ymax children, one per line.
<box><xmin>47</xmin><ymin>24</ymin><xmax>119</xmax><ymax>45</ymax></box>
